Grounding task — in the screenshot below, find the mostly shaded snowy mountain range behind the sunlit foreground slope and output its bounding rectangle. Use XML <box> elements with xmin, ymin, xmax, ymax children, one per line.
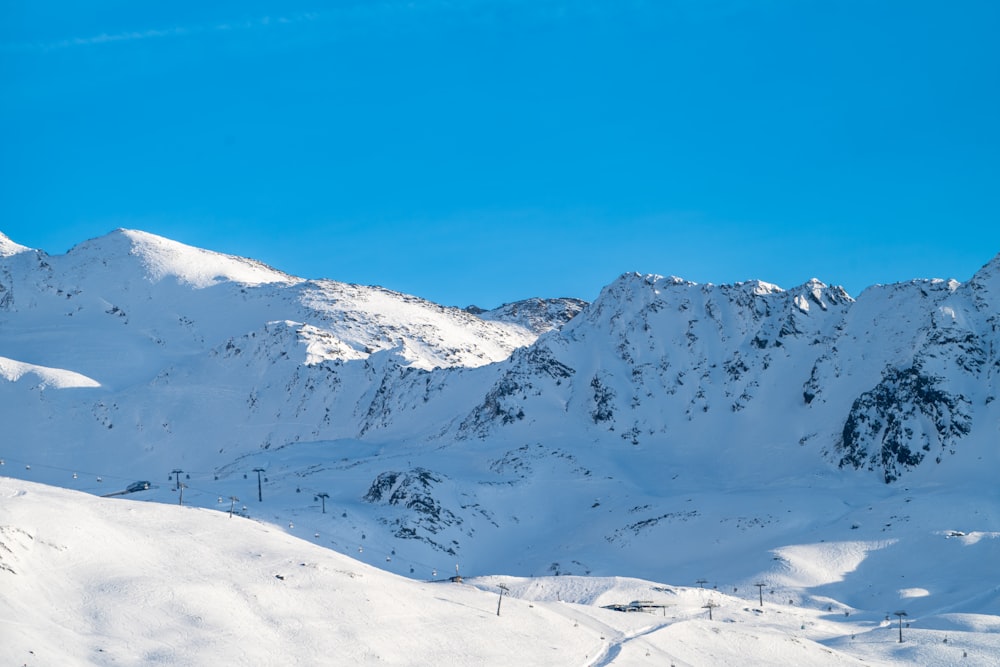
<box><xmin>0</xmin><ymin>230</ymin><xmax>1000</xmax><ymax>640</ymax></box>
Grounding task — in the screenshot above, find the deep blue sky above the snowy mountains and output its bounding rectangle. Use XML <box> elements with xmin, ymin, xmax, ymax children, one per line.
<box><xmin>0</xmin><ymin>0</ymin><xmax>1000</xmax><ymax>307</ymax></box>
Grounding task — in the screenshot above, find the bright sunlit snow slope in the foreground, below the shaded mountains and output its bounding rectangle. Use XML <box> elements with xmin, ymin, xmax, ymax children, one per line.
<box><xmin>0</xmin><ymin>477</ymin><xmax>1000</xmax><ymax>666</ymax></box>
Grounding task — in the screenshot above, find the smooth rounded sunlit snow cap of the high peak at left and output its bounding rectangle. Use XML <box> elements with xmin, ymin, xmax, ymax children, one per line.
<box><xmin>67</xmin><ymin>229</ymin><xmax>301</xmax><ymax>287</ymax></box>
